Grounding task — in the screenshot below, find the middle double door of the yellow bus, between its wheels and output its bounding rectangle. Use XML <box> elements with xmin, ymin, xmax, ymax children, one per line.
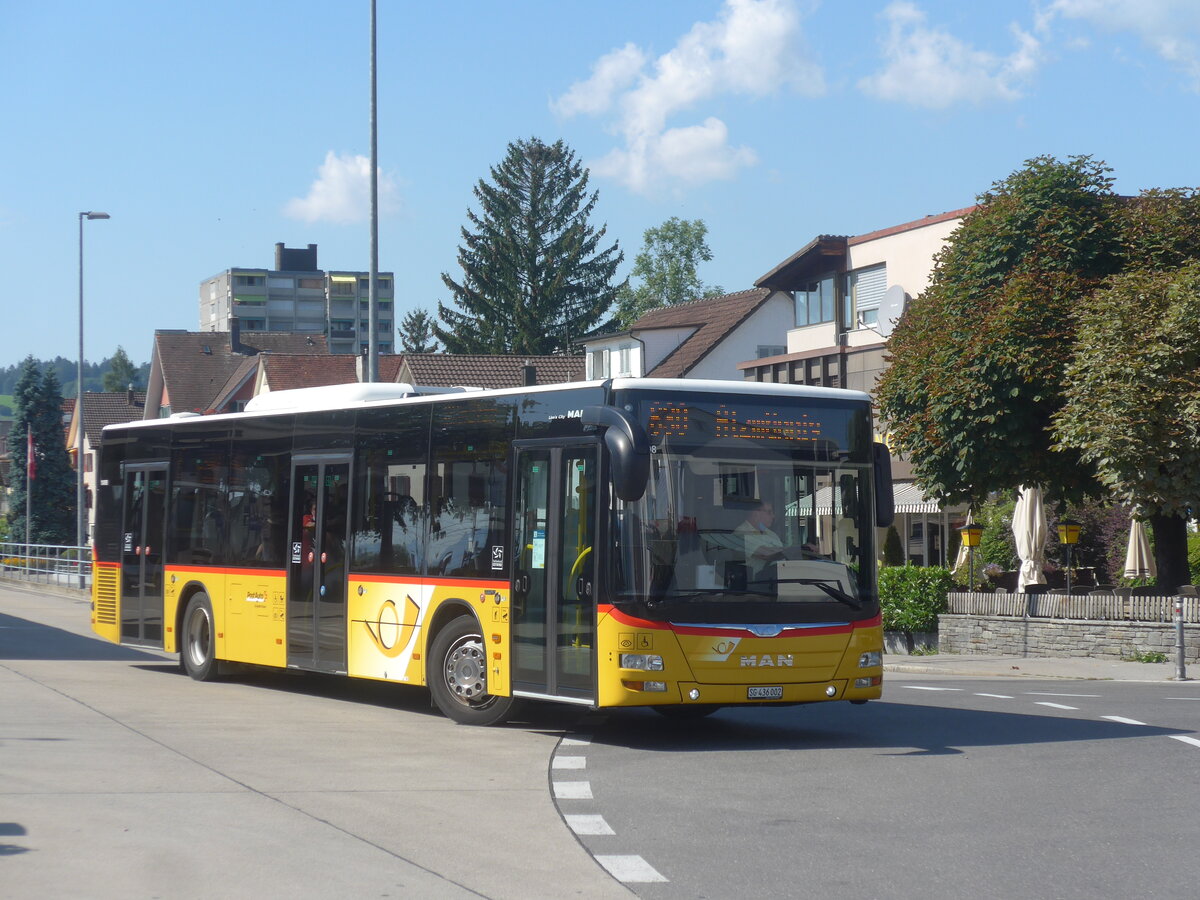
<box><xmin>288</xmin><ymin>457</ymin><xmax>350</xmax><ymax>672</ymax></box>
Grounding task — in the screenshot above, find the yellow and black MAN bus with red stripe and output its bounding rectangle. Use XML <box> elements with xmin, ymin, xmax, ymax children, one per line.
<box><xmin>92</xmin><ymin>378</ymin><xmax>892</xmax><ymax>725</ymax></box>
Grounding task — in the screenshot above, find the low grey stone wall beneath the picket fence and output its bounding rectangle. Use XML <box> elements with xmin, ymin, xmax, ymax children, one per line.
<box><xmin>937</xmin><ymin>613</ymin><xmax>1200</xmax><ymax>664</ymax></box>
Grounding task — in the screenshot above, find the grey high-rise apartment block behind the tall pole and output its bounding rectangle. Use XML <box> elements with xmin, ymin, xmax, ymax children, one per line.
<box><xmin>200</xmin><ymin>244</ymin><xmax>396</xmax><ymax>354</ymax></box>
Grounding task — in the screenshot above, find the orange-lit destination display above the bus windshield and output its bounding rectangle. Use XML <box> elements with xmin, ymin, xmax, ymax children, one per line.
<box><xmin>647</xmin><ymin>403</ymin><xmax>822</xmax><ymax>444</ymax></box>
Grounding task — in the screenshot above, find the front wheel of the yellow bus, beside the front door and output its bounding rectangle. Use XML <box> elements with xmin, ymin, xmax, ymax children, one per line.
<box><xmin>428</xmin><ymin>616</ymin><xmax>512</xmax><ymax>725</ymax></box>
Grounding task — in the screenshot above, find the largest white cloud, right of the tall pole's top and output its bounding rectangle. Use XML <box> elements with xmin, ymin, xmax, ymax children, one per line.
<box><xmin>551</xmin><ymin>0</ymin><xmax>824</xmax><ymax>192</ymax></box>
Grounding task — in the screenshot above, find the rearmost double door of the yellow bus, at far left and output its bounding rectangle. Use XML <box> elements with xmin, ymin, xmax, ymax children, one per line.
<box><xmin>121</xmin><ymin>463</ymin><xmax>167</xmax><ymax>647</ymax></box>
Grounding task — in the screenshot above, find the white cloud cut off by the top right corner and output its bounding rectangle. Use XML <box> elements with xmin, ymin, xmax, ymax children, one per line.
<box><xmin>1039</xmin><ymin>0</ymin><xmax>1200</xmax><ymax>90</ymax></box>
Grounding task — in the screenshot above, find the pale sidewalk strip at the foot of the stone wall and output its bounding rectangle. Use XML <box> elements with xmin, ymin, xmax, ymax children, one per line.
<box><xmin>883</xmin><ymin>653</ymin><xmax>1200</xmax><ymax>690</ymax></box>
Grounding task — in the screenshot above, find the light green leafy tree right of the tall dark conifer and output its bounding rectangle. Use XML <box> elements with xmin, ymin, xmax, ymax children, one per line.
<box><xmin>616</xmin><ymin>216</ymin><xmax>725</xmax><ymax>329</ymax></box>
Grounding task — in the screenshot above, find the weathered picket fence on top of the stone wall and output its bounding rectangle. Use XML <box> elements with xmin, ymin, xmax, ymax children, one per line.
<box><xmin>947</xmin><ymin>592</ymin><xmax>1200</xmax><ymax>625</ymax></box>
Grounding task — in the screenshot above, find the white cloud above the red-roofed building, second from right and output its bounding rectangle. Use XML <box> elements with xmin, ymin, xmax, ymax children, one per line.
<box><xmin>858</xmin><ymin>0</ymin><xmax>1040</xmax><ymax>109</ymax></box>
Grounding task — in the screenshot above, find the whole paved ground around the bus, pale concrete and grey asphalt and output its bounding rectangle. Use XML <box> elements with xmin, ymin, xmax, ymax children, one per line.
<box><xmin>0</xmin><ymin>586</ymin><xmax>1200</xmax><ymax>900</ymax></box>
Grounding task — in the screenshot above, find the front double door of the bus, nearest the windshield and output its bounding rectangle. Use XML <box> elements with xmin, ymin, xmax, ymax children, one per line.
<box><xmin>512</xmin><ymin>443</ymin><xmax>599</xmax><ymax>702</ymax></box>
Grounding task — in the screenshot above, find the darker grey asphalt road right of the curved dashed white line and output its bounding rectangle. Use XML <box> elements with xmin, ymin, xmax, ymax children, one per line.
<box><xmin>556</xmin><ymin>676</ymin><xmax>1200</xmax><ymax>900</ymax></box>
